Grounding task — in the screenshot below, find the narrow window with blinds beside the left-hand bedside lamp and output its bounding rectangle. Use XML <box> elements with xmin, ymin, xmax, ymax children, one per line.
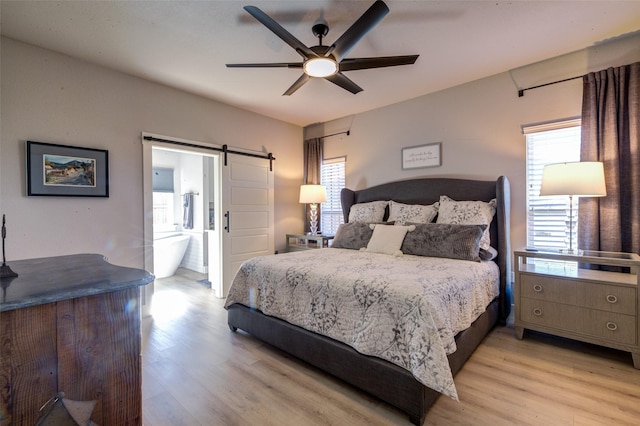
<box><xmin>320</xmin><ymin>157</ymin><xmax>347</xmax><ymax>235</ymax></box>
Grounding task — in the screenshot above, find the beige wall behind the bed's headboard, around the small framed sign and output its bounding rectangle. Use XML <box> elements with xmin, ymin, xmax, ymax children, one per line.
<box><xmin>305</xmin><ymin>34</ymin><xmax>640</xmax><ymax>253</ymax></box>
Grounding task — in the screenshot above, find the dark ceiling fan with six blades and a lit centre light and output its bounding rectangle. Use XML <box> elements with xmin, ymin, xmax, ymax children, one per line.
<box><xmin>227</xmin><ymin>0</ymin><xmax>419</xmax><ymax>96</ymax></box>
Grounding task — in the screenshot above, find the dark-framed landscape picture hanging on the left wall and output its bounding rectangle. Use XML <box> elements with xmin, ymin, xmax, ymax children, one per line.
<box><xmin>26</xmin><ymin>141</ymin><xmax>109</xmax><ymax>197</ymax></box>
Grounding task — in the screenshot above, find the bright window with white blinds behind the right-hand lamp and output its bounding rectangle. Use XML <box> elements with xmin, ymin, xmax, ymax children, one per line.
<box><xmin>523</xmin><ymin>120</ymin><xmax>580</xmax><ymax>250</ymax></box>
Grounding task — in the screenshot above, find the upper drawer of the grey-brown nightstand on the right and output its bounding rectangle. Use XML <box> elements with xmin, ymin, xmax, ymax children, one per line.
<box><xmin>520</xmin><ymin>274</ymin><xmax>637</xmax><ymax>315</ymax></box>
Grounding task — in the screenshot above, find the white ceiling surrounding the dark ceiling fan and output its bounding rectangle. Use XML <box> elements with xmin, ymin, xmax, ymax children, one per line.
<box><xmin>0</xmin><ymin>0</ymin><xmax>640</xmax><ymax>126</ymax></box>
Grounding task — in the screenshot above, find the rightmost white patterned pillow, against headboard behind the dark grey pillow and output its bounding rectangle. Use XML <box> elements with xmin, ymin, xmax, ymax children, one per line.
<box><xmin>436</xmin><ymin>195</ymin><xmax>496</xmax><ymax>250</ymax></box>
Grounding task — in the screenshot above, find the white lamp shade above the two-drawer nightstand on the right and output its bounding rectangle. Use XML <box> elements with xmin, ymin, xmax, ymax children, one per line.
<box><xmin>540</xmin><ymin>161</ymin><xmax>607</xmax><ymax>197</ymax></box>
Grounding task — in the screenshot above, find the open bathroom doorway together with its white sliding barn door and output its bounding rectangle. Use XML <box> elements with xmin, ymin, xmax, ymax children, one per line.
<box><xmin>143</xmin><ymin>134</ymin><xmax>274</xmax><ymax>310</ymax></box>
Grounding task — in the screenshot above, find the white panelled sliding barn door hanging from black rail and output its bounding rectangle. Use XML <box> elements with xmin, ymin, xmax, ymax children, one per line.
<box><xmin>217</xmin><ymin>154</ymin><xmax>274</xmax><ymax>297</ymax></box>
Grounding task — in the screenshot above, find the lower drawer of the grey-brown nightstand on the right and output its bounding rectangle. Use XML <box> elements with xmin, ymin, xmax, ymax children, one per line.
<box><xmin>520</xmin><ymin>297</ymin><xmax>637</xmax><ymax>345</ymax></box>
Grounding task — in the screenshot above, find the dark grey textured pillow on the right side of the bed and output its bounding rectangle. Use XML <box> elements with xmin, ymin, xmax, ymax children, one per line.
<box><xmin>400</xmin><ymin>223</ymin><xmax>487</xmax><ymax>262</ymax></box>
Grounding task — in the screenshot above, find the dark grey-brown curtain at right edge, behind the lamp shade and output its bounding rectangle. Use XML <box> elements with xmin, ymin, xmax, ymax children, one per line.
<box><xmin>578</xmin><ymin>62</ymin><xmax>640</xmax><ymax>253</ymax></box>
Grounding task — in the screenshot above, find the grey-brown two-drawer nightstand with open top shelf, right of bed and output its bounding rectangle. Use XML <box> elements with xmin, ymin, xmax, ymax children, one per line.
<box><xmin>514</xmin><ymin>250</ymin><xmax>640</xmax><ymax>369</ymax></box>
